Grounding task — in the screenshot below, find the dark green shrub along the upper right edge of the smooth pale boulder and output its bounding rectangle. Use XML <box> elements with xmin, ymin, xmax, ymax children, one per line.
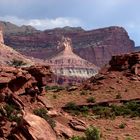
<box><xmin>33</xmin><ymin>108</ymin><xmax>55</xmax><ymax>128</ymax></box>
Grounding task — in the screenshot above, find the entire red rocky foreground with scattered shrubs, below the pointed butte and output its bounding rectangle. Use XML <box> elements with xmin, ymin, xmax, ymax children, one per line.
<box><xmin>0</xmin><ymin>52</ymin><xmax>140</xmax><ymax>140</ymax></box>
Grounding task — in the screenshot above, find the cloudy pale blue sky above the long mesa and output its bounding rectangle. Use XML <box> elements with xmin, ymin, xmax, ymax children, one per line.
<box><xmin>0</xmin><ymin>0</ymin><xmax>140</xmax><ymax>46</ymax></box>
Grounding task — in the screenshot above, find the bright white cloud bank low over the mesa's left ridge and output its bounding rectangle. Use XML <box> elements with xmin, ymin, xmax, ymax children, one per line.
<box><xmin>0</xmin><ymin>16</ymin><xmax>83</xmax><ymax>30</ymax></box>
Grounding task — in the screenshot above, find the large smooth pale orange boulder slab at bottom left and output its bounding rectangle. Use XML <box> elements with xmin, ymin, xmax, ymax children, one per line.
<box><xmin>21</xmin><ymin>112</ymin><xmax>56</xmax><ymax>140</ymax></box>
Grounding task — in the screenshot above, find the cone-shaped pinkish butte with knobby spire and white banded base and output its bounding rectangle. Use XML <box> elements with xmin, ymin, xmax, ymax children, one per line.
<box><xmin>46</xmin><ymin>37</ymin><xmax>99</xmax><ymax>79</ymax></box>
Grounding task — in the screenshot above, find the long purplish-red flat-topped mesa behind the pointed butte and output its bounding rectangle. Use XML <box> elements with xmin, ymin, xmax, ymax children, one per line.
<box><xmin>1</xmin><ymin>22</ymin><xmax>134</xmax><ymax>66</ymax></box>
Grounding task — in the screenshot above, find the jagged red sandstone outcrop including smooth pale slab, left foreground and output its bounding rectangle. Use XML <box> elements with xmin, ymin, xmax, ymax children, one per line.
<box><xmin>0</xmin><ymin>66</ymin><xmax>56</xmax><ymax>140</ymax></box>
